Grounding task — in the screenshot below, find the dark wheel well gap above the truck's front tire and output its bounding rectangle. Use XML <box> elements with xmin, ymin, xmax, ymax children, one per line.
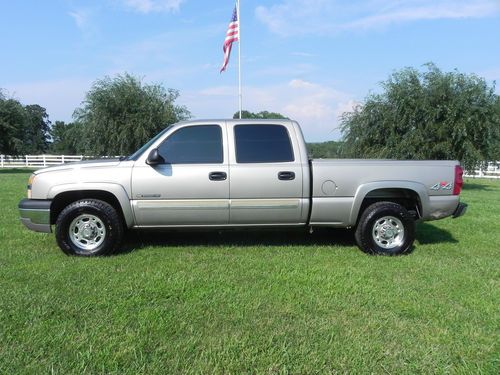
<box><xmin>50</xmin><ymin>190</ymin><xmax>125</xmax><ymax>224</ymax></box>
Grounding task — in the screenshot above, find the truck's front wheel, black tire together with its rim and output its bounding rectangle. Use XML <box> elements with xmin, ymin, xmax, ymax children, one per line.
<box><xmin>56</xmin><ymin>199</ymin><xmax>124</xmax><ymax>256</ymax></box>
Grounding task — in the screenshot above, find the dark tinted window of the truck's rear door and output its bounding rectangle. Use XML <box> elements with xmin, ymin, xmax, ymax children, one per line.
<box><xmin>234</xmin><ymin>125</ymin><xmax>294</xmax><ymax>163</ymax></box>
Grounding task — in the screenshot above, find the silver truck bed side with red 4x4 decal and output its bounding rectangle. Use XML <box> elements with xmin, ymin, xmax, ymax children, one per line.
<box><xmin>310</xmin><ymin>159</ymin><xmax>459</xmax><ymax>227</ymax></box>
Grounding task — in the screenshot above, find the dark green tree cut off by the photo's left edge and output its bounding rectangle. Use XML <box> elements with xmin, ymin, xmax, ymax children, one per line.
<box><xmin>0</xmin><ymin>92</ymin><xmax>26</xmax><ymax>155</ymax></box>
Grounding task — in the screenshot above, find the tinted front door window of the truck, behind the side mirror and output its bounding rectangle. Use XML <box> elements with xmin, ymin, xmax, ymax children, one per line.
<box><xmin>158</xmin><ymin>125</ymin><xmax>224</xmax><ymax>164</ymax></box>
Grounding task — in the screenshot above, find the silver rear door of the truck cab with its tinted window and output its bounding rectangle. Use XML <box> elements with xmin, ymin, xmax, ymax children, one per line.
<box><xmin>228</xmin><ymin>123</ymin><xmax>303</xmax><ymax>225</ymax></box>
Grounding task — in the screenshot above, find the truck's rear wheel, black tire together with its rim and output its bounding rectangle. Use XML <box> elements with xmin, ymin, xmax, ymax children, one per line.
<box><xmin>354</xmin><ymin>202</ymin><xmax>415</xmax><ymax>255</ymax></box>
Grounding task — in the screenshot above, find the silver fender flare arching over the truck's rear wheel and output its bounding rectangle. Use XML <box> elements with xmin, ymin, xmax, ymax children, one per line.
<box><xmin>349</xmin><ymin>180</ymin><xmax>429</xmax><ymax>226</ymax></box>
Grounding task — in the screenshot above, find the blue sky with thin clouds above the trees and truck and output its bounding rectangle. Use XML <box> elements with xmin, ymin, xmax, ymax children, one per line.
<box><xmin>0</xmin><ymin>0</ymin><xmax>500</xmax><ymax>141</ymax></box>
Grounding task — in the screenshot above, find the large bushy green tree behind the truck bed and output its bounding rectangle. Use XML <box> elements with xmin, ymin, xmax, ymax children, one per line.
<box><xmin>341</xmin><ymin>64</ymin><xmax>500</xmax><ymax>169</ymax></box>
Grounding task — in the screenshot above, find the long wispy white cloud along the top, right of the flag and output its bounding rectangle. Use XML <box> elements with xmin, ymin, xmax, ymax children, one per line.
<box><xmin>255</xmin><ymin>0</ymin><xmax>500</xmax><ymax>36</ymax></box>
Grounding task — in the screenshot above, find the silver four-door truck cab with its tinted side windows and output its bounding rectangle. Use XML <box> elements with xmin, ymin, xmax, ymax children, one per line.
<box><xmin>131</xmin><ymin>120</ymin><xmax>310</xmax><ymax>227</ymax></box>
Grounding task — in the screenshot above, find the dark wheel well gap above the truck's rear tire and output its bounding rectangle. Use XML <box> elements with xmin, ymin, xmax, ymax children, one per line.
<box><xmin>356</xmin><ymin>188</ymin><xmax>422</xmax><ymax>223</ymax></box>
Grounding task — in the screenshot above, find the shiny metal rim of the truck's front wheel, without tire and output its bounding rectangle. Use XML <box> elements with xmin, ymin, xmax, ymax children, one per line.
<box><xmin>69</xmin><ymin>214</ymin><xmax>106</xmax><ymax>253</ymax></box>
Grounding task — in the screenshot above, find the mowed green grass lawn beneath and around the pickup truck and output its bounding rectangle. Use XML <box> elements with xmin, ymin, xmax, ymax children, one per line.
<box><xmin>0</xmin><ymin>171</ymin><xmax>500</xmax><ymax>374</ymax></box>
